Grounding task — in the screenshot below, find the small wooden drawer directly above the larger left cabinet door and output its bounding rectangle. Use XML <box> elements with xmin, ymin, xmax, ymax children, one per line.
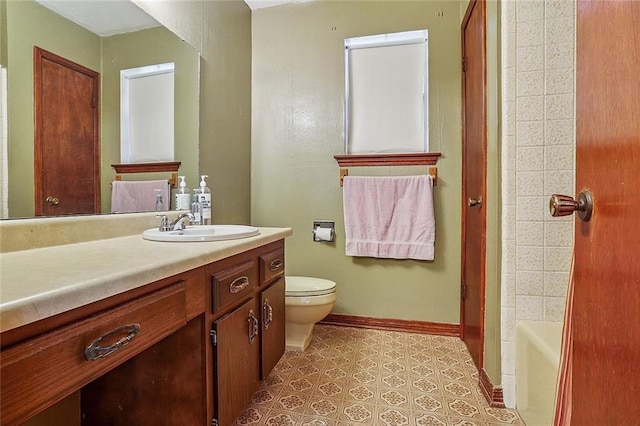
<box><xmin>211</xmin><ymin>260</ymin><xmax>257</xmax><ymax>312</ymax></box>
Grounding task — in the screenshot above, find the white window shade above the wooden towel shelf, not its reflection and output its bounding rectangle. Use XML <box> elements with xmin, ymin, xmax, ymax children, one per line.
<box><xmin>345</xmin><ymin>30</ymin><xmax>428</xmax><ymax>154</ymax></box>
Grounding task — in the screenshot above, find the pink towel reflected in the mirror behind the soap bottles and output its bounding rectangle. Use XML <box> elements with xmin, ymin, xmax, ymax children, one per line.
<box><xmin>111</xmin><ymin>180</ymin><xmax>170</xmax><ymax>213</ymax></box>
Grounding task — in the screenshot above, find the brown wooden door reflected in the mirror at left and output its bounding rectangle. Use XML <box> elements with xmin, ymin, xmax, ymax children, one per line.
<box><xmin>34</xmin><ymin>47</ymin><xmax>100</xmax><ymax>216</ymax></box>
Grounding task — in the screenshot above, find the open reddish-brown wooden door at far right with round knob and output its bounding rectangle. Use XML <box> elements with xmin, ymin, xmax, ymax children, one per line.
<box><xmin>571</xmin><ymin>0</ymin><xmax>640</xmax><ymax>425</ymax></box>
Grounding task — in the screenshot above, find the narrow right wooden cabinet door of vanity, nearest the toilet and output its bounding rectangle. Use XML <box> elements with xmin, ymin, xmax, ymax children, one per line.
<box><xmin>260</xmin><ymin>277</ymin><xmax>285</xmax><ymax>380</ymax></box>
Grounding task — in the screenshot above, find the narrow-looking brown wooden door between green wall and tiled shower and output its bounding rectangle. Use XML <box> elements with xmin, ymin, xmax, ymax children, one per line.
<box><xmin>460</xmin><ymin>0</ymin><xmax>487</xmax><ymax>369</ymax></box>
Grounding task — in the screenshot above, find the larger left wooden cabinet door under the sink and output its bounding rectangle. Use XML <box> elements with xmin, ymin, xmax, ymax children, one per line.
<box><xmin>213</xmin><ymin>298</ymin><xmax>260</xmax><ymax>426</ymax></box>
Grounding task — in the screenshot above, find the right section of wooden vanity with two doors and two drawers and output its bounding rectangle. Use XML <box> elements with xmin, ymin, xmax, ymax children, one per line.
<box><xmin>207</xmin><ymin>241</ymin><xmax>285</xmax><ymax>426</ymax></box>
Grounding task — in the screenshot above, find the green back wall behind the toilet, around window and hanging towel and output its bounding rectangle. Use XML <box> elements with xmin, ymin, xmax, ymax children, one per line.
<box><xmin>251</xmin><ymin>1</ymin><xmax>461</xmax><ymax>324</ymax></box>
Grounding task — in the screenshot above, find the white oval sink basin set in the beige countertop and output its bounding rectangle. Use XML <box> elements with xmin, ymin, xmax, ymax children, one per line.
<box><xmin>142</xmin><ymin>225</ymin><xmax>260</xmax><ymax>242</ymax></box>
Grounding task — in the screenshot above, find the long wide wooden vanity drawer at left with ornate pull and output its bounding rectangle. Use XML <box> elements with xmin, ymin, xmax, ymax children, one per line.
<box><xmin>0</xmin><ymin>281</ymin><xmax>187</xmax><ymax>425</ymax></box>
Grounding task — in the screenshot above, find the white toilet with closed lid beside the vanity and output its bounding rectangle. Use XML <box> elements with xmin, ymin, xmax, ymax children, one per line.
<box><xmin>285</xmin><ymin>276</ymin><xmax>336</xmax><ymax>351</ymax></box>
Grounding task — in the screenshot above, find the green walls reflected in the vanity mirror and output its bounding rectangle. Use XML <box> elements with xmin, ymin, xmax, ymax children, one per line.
<box><xmin>0</xmin><ymin>0</ymin><xmax>200</xmax><ymax>218</ymax></box>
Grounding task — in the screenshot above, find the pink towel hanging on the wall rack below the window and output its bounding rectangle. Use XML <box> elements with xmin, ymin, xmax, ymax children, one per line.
<box><xmin>343</xmin><ymin>176</ymin><xmax>435</xmax><ymax>260</ymax></box>
